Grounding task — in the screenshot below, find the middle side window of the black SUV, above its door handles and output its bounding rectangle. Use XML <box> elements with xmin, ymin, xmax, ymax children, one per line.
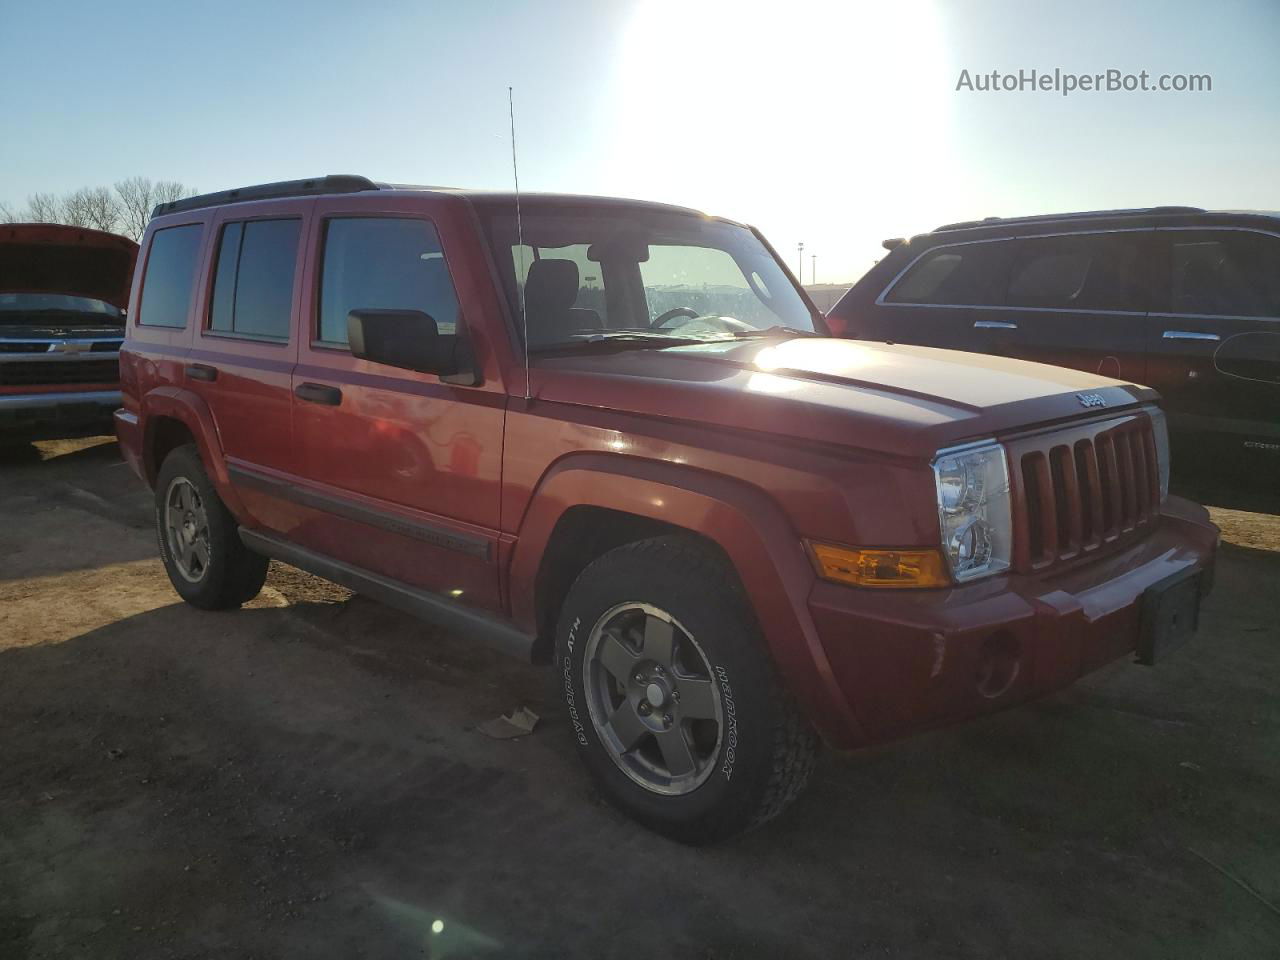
<box><xmin>1005</xmin><ymin>233</ymin><xmax>1146</xmax><ymax>311</ymax></box>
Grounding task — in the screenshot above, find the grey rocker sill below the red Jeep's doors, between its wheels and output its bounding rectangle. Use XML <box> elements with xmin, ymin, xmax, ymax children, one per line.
<box><xmin>239</xmin><ymin>527</ymin><xmax>534</xmax><ymax>663</ymax></box>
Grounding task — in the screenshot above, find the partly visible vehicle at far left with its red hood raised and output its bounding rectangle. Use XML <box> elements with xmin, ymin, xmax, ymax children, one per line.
<box><xmin>0</xmin><ymin>223</ymin><xmax>138</xmax><ymax>442</ymax></box>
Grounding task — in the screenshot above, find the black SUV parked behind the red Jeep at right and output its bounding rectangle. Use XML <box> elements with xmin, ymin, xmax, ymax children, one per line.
<box><xmin>828</xmin><ymin>206</ymin><xmax>1280</xmax><ymax>465</ymax></box>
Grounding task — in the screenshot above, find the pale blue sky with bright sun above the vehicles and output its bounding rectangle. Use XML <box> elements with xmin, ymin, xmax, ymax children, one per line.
<box><xmin>0</xmin><ymin>0</ymin><xmax>1280</xmax><ymax>283</ymax></box>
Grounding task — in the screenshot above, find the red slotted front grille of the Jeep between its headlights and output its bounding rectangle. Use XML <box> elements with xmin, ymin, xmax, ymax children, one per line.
<box><xmin>1011</xmin><ymin>415</ymin><xmax>1160</xmax><ymax>572</ymax></box>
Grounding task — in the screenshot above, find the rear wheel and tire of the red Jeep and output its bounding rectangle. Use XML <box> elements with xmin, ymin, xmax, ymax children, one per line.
<box><xmin>156</xmin><ymin>444</ymin><xmax>268</xmax><ymax>611</ymax></box>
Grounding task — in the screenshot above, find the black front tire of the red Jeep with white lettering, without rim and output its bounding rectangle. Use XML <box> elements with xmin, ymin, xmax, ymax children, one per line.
<box><xmin>556</xmin><ymin>538</ymin><xmax>781</xmax><ymax>844</ymax></box>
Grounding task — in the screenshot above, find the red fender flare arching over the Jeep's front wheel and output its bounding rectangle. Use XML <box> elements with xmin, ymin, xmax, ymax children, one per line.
<box><xmin>508</xmin><ymin>453</ymin><xmax>861</xmax><ymax>741</ymax></box>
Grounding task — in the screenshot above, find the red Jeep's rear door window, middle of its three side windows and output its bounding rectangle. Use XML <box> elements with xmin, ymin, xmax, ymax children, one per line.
<box><xmin>209</xmin><ymin>219</ymin><xmax>302</xmax><ymax>340</ymax></box>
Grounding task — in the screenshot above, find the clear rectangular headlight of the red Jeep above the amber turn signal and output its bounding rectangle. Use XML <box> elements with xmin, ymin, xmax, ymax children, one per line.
<box><xmin>933</xmin><ymin>443</ymin><xmax>1014</xmax><ymax>581</ymax></box>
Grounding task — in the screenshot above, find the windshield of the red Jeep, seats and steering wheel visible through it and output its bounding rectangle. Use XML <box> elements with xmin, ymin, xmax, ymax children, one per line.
<box><xmin>486</xmin><ymin>204</ymin><xmax>815</xmax><ymax>349</ymax></box>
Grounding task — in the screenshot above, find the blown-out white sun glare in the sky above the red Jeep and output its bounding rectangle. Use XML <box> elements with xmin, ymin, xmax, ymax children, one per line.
<box><xmin>609</xmin><ymin>0</ymin><xmax>950</xmax><ymax>280</ymax></box>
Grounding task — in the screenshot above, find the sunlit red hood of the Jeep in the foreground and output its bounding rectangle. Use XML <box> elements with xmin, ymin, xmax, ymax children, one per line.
<box><xmin>534</xmin><ymin>338</ymin><xmax>1157</xmax><ymax>458</ymax></box>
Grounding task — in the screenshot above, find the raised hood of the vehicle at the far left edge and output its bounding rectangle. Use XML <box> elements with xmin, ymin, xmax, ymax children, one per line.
<box><xmin>0</xmin><ymin>223</ymin><xmax>138</xmax><ymax>310</ymax></box>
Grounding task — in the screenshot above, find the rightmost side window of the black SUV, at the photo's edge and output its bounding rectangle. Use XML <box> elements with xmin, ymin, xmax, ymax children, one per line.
<box><xmin>1167</xmin><ymin>230</ymin><xmax>1280</xmax><ymax>316</ymax></box>
